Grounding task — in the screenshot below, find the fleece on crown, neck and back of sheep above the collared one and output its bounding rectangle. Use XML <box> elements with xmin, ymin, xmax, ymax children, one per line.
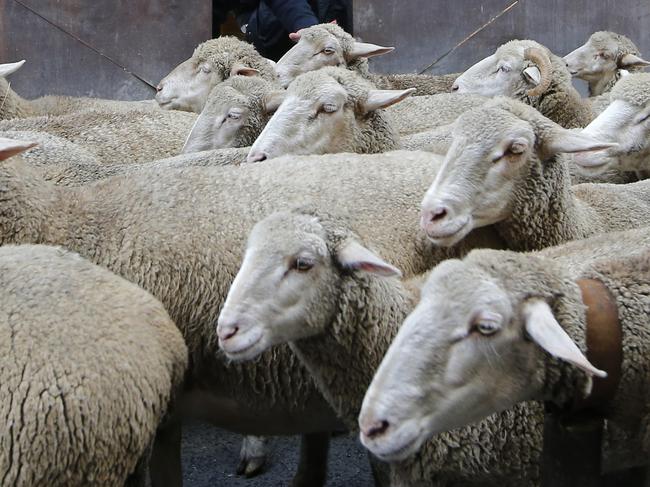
<box><xmin>477</xmin><ymin>98</ymin><xmax>650</xmax><ymax>250</ymax></box>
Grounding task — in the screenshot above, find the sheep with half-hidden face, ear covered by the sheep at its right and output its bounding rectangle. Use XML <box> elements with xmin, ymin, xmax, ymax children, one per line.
<box><xmin>182</xmin><ymin>76</ymin><xmax>275</xmax><ymax>153</ymax></box>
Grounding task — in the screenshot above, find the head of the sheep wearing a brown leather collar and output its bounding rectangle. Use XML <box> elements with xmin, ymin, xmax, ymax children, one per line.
<box><xmin>359</xmin><ymin>250</ymin><xmax>603</xmax><ymax>461</ymax></box>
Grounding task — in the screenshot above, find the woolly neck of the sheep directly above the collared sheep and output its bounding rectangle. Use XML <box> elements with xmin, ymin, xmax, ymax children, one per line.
<box><xmin>497</xmin><ymin>157</ymin><xmax>590</xmax><ymax>251</ymax></box>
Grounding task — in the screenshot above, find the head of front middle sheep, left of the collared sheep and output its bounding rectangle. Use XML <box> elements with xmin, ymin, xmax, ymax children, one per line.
<box><xmin>217</xmin><ymin>210</ymin><xmax>399</xmax><ymax>360</ymax></box>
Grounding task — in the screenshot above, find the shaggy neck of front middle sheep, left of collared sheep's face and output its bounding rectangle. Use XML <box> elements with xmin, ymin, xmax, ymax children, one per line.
<box><xmin>290</xmin><ymin>275</ymin><xmax>415</xmax><ymax>430</ymax></box>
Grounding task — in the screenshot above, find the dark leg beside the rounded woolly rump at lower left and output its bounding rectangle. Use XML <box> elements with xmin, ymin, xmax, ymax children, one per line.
<box><xmin>149</xmin><ymin>415</ymin><xmax>183</xmax><ymax>487</ymax></box>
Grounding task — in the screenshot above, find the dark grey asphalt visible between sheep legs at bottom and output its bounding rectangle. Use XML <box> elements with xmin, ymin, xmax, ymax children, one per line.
<box><xmin>182</xmin><ymin>422</ymin><xmax>373</xmax><ymax>487</ymax></box>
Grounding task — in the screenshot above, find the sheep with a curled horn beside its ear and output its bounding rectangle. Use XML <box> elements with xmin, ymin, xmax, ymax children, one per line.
<box><xmin>452</xmin><ymin>40</ymin><xmax>593</xmax><ymax>128</ymax></box>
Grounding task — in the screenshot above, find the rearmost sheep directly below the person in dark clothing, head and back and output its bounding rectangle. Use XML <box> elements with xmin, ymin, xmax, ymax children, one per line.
<box><xmin>275</xmin><ymin>23</ymin><xmax>460</xmax><ymax>95</ymax></box>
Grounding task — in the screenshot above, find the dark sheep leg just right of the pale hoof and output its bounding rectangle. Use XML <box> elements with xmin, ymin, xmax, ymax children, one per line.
<box><xmin>291</xmin><ymin>431</ymin><xmax>330</xmax><ymax>487</ymax></box>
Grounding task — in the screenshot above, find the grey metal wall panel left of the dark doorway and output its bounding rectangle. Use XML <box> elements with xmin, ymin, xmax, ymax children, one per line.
<box><xmin>0</xmin><ymin>0</ymin><xmax>212</xmax><ymax>100</ymax></box>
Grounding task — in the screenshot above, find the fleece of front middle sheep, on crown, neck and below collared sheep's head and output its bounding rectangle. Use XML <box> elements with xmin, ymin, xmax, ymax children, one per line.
<box><xmin>280</xmin><ymin>210</ymin><xmax>543</xmax><ymax>486</ymax></box>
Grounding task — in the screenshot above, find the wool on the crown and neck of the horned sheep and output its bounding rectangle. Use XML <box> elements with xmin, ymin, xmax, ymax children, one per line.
<box><xmin>495</xmin><ymin>40</ymin><xmax>593</xmax><ymax>128</ymax></box>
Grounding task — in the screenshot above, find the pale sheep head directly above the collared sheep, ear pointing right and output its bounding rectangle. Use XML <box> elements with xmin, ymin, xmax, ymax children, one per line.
<box><xmin>420</xmin><ymin>98</ymin><xmax>615</xmax><ymax>246</ymax></box>
